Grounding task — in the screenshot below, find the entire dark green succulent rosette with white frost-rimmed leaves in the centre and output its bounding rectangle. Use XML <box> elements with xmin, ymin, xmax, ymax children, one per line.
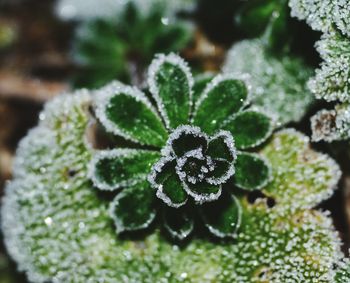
<box><xmin>89</xmin><ymin>54</ymin><xmax>273</xmax><ymax>240</ymax></box>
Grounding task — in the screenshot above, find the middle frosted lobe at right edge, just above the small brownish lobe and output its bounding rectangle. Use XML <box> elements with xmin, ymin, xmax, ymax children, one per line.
<box><xmin>309</xmin><ymin>33</ymin><xmax>350</xmax><ymax>102</ymax></box>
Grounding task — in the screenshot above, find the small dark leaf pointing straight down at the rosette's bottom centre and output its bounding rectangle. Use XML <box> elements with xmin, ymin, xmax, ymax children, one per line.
<box><xmin>163</xmin><ymin>206</ymin><xmax>194</xmax><ymax>241</ymax></box>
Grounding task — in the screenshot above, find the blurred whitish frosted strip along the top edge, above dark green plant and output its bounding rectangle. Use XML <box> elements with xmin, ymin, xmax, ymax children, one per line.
<box><xmin>55</xmin><ymin>0</ymin><xmax>194</xmax><ymax>22</ymax></box>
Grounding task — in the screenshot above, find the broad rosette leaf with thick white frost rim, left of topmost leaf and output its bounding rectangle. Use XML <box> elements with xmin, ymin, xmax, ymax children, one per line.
<box><xmin>96</xmin><ymin>83</ymin><xmax>167</xmax><ymax>147</ymax></box>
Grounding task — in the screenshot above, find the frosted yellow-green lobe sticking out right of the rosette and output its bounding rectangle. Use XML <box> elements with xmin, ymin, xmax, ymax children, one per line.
<box><xmin>261</xmin><ymin>129</ymin><xmax>341</xmax><ymax>210</ymax></box>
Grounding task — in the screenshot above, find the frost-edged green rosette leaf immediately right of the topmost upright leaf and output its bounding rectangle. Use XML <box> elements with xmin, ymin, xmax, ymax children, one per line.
<box><xmin>193</xmin><ymin>75</ymin><xmax>248</xmax><ymax>134</ymax></box>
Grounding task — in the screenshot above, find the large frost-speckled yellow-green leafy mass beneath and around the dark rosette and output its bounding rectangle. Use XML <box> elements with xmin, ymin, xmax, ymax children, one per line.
<box><xmin>1</xmin><ymin>87</ymin><xmax>349</xmax><ymax>283</ymax></box>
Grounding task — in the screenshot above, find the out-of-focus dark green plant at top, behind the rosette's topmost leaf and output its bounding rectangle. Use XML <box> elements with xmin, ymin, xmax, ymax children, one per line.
<box><xmin>59</xmin><ymin>0</ymin><xmax>192</xmax><ymax>88</ymax></box>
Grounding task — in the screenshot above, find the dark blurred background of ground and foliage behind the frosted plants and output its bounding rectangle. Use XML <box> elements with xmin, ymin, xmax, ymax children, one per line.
<box><xmin>0</xmin><ymin>0</ymin><xmax>350</xmax><ymax>283</ymax></box>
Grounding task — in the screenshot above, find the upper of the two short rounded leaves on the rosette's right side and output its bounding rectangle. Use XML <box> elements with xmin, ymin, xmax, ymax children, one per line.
<box><xmin>223</xmin><ymin>110</ymin><xmax>272</xmax><ymax>149</ymax></box>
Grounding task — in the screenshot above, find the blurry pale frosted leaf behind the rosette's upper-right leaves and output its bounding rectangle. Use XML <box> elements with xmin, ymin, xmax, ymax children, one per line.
<box><xmin>223</xmin><ymin>39</ymin><xmax>313</xmax><ymax>125</ymax></box>
